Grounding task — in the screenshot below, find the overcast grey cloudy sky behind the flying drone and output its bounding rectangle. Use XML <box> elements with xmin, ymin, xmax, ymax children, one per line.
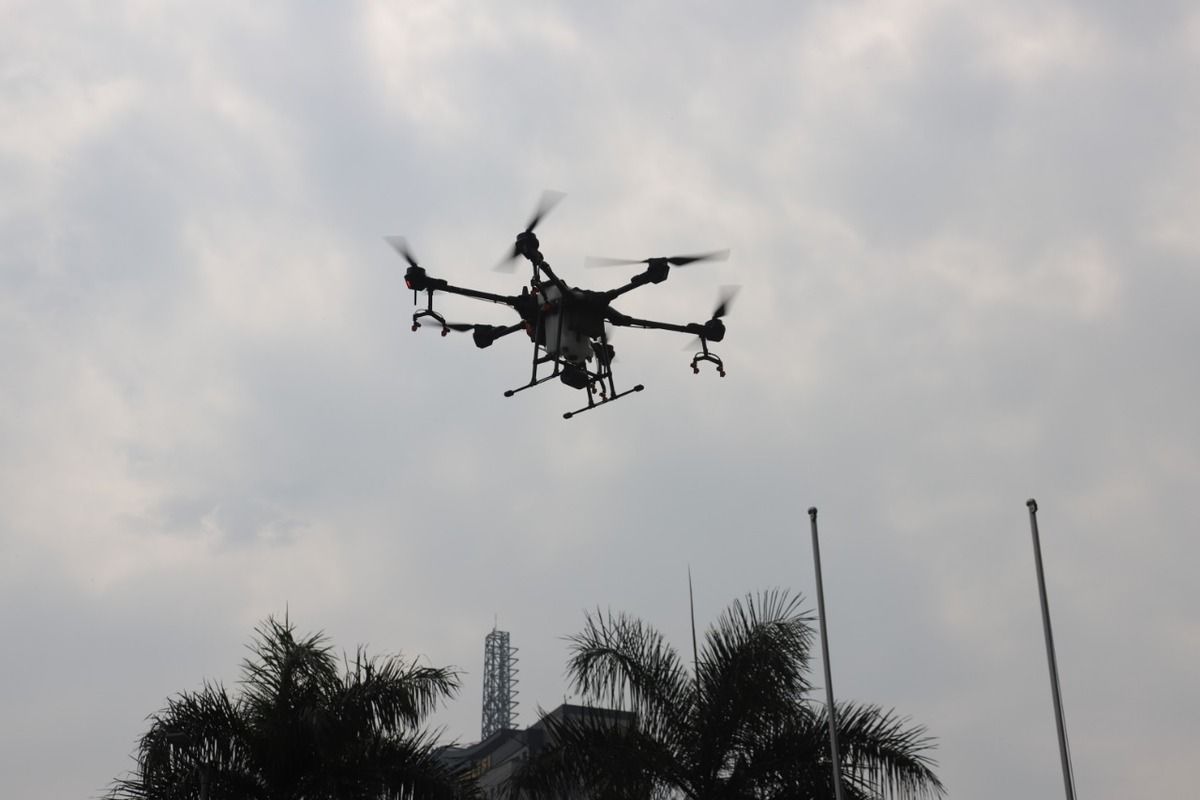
<box><xmin>0</xmin><ymin>0</ymin><xmax>1200</xmax><ymax>800</ymax></box>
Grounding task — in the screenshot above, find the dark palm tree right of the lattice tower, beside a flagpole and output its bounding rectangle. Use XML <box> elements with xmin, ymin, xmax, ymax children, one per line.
<box><xmin>509</xmin><ymin>591</ymin><xmax>943</xmax><ymax>800</ymax></box>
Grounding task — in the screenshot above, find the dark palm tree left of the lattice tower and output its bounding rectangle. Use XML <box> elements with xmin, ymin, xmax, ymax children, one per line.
<box><xmin>108</xmin><ymin>619</ymin><xmax>462</xmax><ymax>800</ymax></box>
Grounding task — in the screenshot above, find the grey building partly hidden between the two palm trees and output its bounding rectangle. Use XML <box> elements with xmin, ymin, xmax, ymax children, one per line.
<box><xmin>439</xmin><ymin>703</ymin><xmax>634</xmax><ymax>799</ymax></box>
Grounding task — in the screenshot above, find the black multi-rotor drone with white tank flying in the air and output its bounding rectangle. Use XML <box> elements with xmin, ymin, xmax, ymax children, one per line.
<box><xmin>385</xmin><ymin>192</ymin><xmax>736</xmax><ymax>420</ymax></box>
